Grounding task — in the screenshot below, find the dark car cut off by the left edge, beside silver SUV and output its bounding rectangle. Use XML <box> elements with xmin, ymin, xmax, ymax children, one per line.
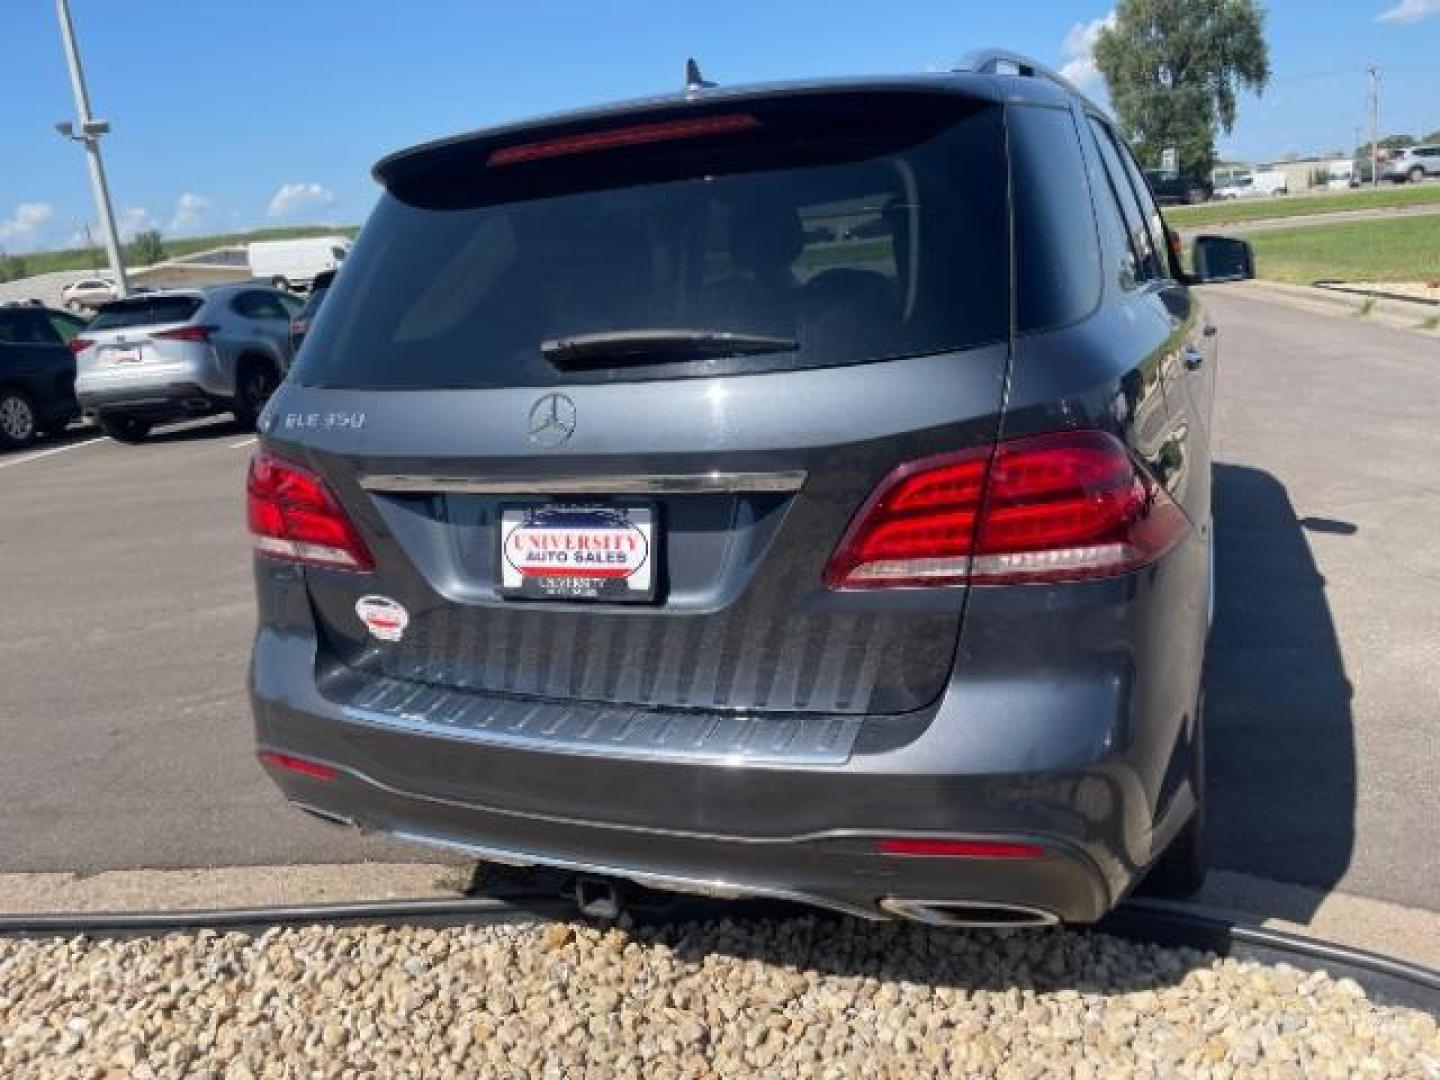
<box><xmin>0</xmin><ymin>304</ymin><xmax>85</xmax><ymax>449</ymax></box>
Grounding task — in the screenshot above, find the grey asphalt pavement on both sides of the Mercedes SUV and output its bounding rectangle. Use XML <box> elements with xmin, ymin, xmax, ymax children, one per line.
<box><xmin>0</xmin><ymin>289</ymin><xmax>1440</xmax><ymax>909</ymax></box>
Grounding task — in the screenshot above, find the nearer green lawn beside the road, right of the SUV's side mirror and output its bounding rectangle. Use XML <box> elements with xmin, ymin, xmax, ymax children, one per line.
<box><xmin>1247</xmin><ymin>213</ymin><xmax>1440</xmax><ymax>285</ymax></box>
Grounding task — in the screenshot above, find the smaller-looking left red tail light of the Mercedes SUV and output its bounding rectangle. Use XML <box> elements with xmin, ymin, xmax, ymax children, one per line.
<box><xmin>245</xmin><ymin>452</ymin><xmax>374</xmax><ymax>570</ymax></box>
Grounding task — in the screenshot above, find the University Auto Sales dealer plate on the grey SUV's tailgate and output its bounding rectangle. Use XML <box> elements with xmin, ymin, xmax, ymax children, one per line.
<box><xmin>500</xmin><ymin>503</ymin><xmax>658</xmax><ymax>602</ymax></box>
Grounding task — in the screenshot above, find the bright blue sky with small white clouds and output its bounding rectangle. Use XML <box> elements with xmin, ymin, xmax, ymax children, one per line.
<box><xmin>0</xmin><ymin>0</ymin><xmax>1440</xmax><ymax>251</ymax></box>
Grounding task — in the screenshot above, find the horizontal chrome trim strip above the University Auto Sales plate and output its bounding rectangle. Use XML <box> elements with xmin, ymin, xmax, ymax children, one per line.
<box><xmin>360</xmin><ymin>469</ymin><xmax>805</xmax><ymax>495</ymax></box>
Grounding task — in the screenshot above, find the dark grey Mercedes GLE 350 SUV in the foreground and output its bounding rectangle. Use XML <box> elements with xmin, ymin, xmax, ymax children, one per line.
<box><xmin>248</xmin><ymin>53</ymin><xmax>1248</xmax><ymax>924</ymax></box>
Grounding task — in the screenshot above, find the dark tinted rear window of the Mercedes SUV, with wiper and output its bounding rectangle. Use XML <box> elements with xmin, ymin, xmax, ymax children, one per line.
<box><xmin>297</xmin><ymin>95</ymin><xmax>1009</xmax><ymax>387</ymax></box>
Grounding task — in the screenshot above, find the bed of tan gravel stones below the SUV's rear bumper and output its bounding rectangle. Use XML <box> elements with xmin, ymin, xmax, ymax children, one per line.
<box><xmin>0</xmin><ymin>919</ymin><xmax>1440</xmax><ymax>1080</ymax></box>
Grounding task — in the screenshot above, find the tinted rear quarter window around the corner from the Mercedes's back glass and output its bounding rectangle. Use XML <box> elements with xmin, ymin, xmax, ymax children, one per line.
<box><xmin>1008</xmin><ymin>105</ymin><xmax>1102</xmax><ymax>333</ymax></box>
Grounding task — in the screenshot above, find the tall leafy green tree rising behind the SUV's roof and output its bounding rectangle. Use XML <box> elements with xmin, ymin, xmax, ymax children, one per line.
<box><xmin>1094</xmin><ymin>0</ymin><xmax>1270</xmax><ymax>176</ymax></box>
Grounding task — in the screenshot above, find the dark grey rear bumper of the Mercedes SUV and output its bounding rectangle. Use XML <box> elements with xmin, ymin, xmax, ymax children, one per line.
<box><xmin>251</xmin><ymin>543</ymin><xmax>1208</xmax><ymax>923</ymax></box>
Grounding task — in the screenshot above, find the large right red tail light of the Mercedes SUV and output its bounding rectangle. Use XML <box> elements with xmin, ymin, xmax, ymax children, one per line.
<box><xmin>825</xmin><ymin>431</ymin><xmax>1189</xmax><ymax>589</ymax></box>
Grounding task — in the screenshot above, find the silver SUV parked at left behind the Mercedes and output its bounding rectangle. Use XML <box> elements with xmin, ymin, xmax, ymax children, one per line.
<box><xmin>73</xmin><ymin>284</ymin><xmax>301</xmax><ymax>442</ymax></box>
